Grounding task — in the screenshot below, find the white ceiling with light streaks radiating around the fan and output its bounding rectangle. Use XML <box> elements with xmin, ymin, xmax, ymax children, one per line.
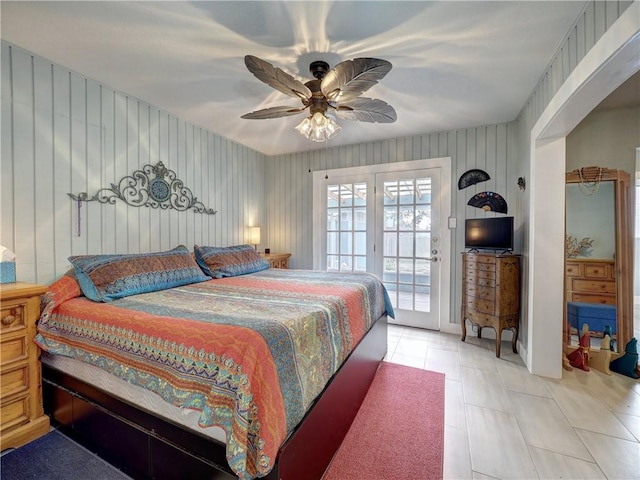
<box><xmin>0</xmin><ymin>0</ymin><xmax>585</xmax><ymax>155</ymax></box>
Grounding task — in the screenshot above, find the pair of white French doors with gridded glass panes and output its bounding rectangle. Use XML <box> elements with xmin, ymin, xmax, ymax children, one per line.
<box><xmin>314</xmin><ymin>168</ymin><xmax>441</xmax><ymax>330</ymax></box>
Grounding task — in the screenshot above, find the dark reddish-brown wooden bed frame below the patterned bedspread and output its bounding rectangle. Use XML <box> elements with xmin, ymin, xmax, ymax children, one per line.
<box><xmin>43</xmin><ymin>315</ymin><xmax>387</xmax><ymax>480</ymax></box>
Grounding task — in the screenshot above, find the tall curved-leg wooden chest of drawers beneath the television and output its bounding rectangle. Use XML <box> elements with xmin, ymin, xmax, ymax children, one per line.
<box><xmin>461</xmin><ymin>253</ymin><xmax>520</xmax><ymax>357</ymax></box>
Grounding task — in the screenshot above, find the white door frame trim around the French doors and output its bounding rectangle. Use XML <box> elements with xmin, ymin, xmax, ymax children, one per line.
<box><xmin>312</xmin><ymin>157</ymin><xmax>460</xmax><ymax>333</ymax></box>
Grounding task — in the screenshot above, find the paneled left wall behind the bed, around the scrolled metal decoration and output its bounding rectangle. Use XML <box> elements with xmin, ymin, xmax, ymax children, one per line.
<box><xmin>0</xmin><ymin>42</ymin><xmax>266</xmax><ymax>283</ymax></box>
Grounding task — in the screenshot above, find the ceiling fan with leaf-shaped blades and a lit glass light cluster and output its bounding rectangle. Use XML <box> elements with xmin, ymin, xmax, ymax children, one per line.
<box><xmin>241</xmin><ymin>55</ymin><xmax>397</xmax><ymax>142</ymax></box>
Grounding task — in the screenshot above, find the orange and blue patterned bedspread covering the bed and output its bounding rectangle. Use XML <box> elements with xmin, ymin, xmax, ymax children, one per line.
<box><xmin>36</xmin><ymin>269</ymin><xmax>393</xmax><ymax>479</ymax></box>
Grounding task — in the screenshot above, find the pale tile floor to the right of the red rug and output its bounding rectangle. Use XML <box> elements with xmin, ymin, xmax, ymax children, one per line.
<box><xmin>386</xmin><ymin>325</ymin><xmax>640</xmax><ymax>480</ymax></box>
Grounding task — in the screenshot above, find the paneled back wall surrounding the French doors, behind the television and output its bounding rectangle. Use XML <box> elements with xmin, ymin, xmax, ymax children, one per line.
<box><xmin>265</xmin><ymin>123</ymin><xmax>522</xmax><ymax>326</ymax></box>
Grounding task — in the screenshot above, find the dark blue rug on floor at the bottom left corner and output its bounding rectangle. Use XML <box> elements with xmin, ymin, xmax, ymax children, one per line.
<box><xmin>0</xmin><ymin>430</ymin><xmax>130</xmax><ymax>480</ymax></box>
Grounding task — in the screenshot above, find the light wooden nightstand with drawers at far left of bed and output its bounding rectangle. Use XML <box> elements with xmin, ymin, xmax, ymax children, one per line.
<box><xmin>0</xmin><ymin>282</ymin><xmax>49</xmax><ymax>450</ymax></box>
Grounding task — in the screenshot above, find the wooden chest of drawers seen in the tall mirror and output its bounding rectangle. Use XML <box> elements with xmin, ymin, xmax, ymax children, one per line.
<box><xmin>564</xmin><ymin>258</ymin><xmax>617</xmax><ymax>305</ymax></box>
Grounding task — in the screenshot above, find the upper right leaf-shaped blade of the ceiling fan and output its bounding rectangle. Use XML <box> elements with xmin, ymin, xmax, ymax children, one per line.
<box><xmin>320</xmin><ymin>58</ymin><xmax>391</xmax><ymax>102</ymax></box>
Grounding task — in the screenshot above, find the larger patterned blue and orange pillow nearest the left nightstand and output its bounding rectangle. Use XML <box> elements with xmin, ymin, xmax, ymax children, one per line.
<box><xmin>69</xmin><ymin>245</ymin><xmax>209</xmax><ymax>302</ymax></box>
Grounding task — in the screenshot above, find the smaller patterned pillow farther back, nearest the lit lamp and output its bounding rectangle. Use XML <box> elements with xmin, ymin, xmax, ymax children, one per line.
<box><xmin>193</xmin><ymin>245</ymin><xmax>269</xmax><ymax>278</ymax></box>
